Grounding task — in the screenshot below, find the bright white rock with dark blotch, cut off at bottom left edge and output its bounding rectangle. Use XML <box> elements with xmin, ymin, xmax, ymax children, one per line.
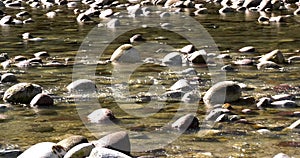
<box><xmin>18</xmin><ymin>142</ymin><xmax>66</xmax><ymax>158</ymax></box>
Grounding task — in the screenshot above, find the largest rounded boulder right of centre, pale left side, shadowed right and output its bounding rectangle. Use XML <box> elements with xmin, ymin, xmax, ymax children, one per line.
<box><xmin>203</xmin><ymin>81</ymin><xmax>242</xmax><ymax>106</ymax></box>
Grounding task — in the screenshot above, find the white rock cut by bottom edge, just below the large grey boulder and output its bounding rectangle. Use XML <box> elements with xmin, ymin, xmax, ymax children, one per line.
<box><xmin>87</xmin><ymin>147</ymin><xmax>131</xmax><ymax>158</ymax></box>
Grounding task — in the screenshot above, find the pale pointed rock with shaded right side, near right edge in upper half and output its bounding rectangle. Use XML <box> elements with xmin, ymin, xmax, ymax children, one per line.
<box><xmin>258</xmin><ymin>49</ymin><xmax>285</xmax><ymax>64</ymax></box>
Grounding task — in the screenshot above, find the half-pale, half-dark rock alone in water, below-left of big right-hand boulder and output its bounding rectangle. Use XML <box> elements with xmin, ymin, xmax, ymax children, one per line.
<box><xmin>171</xmin><ymin>114</ymin><xmax>199</xmax><ymax>131</ymax></box>
